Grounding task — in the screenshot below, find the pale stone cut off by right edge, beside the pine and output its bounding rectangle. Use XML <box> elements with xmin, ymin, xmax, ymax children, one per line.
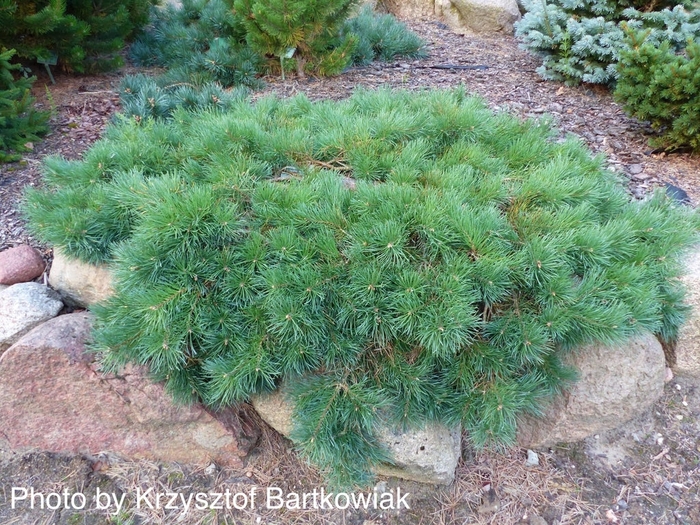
<box><xmin>673</xmin><ymin>247</ymin><xmax>700</xmax><ymax>378</ymax></box>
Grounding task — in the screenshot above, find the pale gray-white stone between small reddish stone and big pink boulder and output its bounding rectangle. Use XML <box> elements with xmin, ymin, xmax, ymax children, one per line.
<box><xmin>0</xmin><ymin>283</ymin><xmax>63</xmax><ymax>353</ymax></box>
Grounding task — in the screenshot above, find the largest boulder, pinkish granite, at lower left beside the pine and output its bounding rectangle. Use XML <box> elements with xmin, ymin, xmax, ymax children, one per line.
<box><xmin>0</xmin><ymin>312</ymin><xmax>254</xmax><ymax>466</ymax></box>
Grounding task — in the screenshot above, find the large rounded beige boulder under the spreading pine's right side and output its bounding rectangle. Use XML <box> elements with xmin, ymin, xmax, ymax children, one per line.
<box><xmin>518</xmin><ymin>334</ymin><xmax>666</xmax><ymax>449</ymax></box>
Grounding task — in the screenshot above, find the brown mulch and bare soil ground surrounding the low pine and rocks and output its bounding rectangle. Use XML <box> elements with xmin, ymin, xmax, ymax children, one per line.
<box><xmin>0</xmin><ymin>16</ymin><xmax>700</xmax><ymax>525</ymax></box>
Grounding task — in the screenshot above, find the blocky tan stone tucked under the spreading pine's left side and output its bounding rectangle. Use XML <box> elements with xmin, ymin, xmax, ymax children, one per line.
<box><xmin>49</xmin><ymin>248</ymin><xmax>113</xmax><ymax>308</ymax></box>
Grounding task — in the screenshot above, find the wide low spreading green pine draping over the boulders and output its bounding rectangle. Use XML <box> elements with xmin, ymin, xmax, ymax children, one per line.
<box><xmin>26</xmin><ymin>90</ymin><xmax>700</xmax><ymax>485</ymax></box>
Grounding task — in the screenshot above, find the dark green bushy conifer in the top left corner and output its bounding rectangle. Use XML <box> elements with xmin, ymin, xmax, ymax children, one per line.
<box><xmin>0</xmin><ymin>0</ymin><xmax>156</xmax><ymax>72</ymax></box>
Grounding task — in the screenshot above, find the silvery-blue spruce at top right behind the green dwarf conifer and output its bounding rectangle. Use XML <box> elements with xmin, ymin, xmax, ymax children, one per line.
<box><xmin>516</xmin><ymin>0</ymin><xmax>700</xmax><ymax>85</ymax></box>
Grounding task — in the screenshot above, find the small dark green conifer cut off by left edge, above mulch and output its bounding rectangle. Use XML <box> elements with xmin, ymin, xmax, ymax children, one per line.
<box><xmin>0</xmin><ymin>49</ymin><xmax>49</xmax><ymax>162</ymax></box>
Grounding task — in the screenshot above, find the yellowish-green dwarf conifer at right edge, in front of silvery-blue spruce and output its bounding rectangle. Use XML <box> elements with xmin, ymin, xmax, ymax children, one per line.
<box><xmin>615</xmin><ymin>24</ymin><xmax>700</xmax><ymax>151</ymax></box>
